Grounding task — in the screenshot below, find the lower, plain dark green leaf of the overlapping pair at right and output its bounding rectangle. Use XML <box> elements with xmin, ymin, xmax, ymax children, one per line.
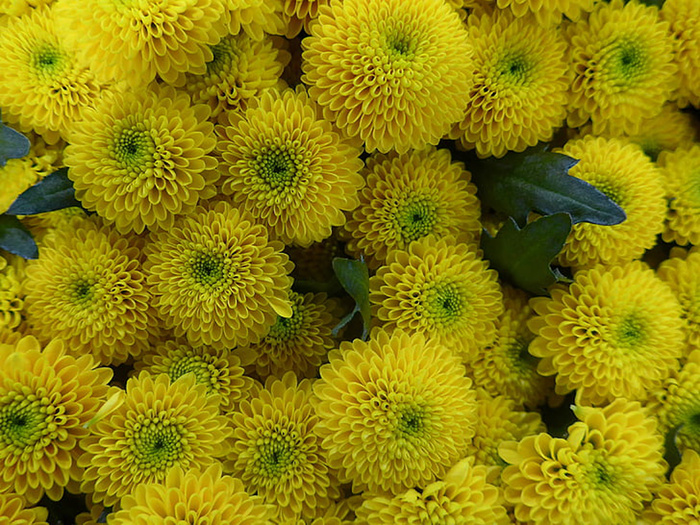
<box><xmin>481</xmin><ymin>213</ymin><xmax>571</xmax><ymax>295</ymax></box>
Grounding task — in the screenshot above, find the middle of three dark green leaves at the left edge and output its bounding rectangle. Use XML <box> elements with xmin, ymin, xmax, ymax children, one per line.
<box><xmin>7</xmin><ymin>168</ymin><xmax>81</xmax><ymax>215</ymax></box>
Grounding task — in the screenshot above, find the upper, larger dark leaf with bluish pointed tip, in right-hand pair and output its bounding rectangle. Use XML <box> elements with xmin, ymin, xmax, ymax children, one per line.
<box><xmin>468</xmin><ymin>148</ymin><xmax>627</xmax><ymax>226</ymax></box>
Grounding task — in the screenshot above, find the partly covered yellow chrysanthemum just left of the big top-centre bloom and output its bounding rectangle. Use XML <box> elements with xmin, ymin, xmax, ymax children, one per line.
<box><xmin>185</xmin><ymin>33</ymin><xmax>291</xmax><ymax>119</ymax></box>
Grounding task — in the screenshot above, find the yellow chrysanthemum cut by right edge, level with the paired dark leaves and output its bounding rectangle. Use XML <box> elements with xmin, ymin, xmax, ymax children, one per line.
<box><xmin>658</xmin><ymin>144</ymin><xmax>700</xmax><ymax>244</ymax></box>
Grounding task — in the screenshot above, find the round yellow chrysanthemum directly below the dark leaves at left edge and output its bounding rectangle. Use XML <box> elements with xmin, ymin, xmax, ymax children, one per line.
<box><xmin>24</xmin><ymin>217</ymin><xmax>159</xmax><ymax>364</ymax></box>
